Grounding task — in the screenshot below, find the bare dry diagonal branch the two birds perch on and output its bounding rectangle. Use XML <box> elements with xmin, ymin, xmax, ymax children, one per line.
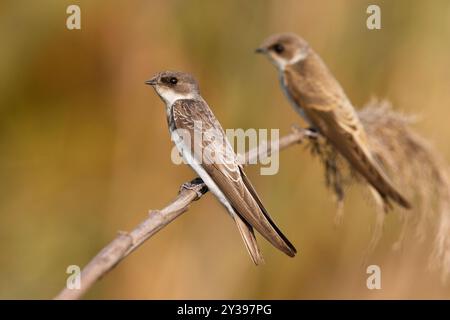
<box><xmin>55</xmin><ymin>128</ymin><xmax>310</xmax><ymax>300</ymax></box>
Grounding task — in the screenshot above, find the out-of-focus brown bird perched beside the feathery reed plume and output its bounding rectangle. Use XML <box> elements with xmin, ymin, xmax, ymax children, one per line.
<box><xmin>256</xmin><ymin>33</ymin><xmax>411</xmax><ymax>209</ymax></box>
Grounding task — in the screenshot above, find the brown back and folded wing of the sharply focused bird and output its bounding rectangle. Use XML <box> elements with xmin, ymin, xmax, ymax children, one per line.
<box><xmin>172</xmin><ymin>100</ymin><xmax>296</xmax><ymax>256</ymax></box>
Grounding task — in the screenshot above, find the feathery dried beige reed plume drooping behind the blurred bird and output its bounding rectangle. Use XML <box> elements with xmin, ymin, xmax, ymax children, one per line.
<box><xmin>309</xmin><ymin>99</ymin><xmax>450</xmax><ymax>282</ymax></box>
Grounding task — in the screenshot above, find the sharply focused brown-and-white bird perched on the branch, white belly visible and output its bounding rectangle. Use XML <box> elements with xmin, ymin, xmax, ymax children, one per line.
<box><xmin>146</xmin><ymin>71</ymin><xmax>296</xmax><ymax>264</ymax></box>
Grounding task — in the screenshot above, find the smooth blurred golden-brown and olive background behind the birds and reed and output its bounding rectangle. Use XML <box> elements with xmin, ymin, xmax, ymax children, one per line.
<box><xmin>0</xmin><ymin>0</ymin><xmax>450</xmax><ymax>299</ymax></box>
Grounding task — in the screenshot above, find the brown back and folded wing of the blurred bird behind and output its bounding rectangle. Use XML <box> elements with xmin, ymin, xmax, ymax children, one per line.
<box><xmin>285</xmin><ymin>53</ymin><xmax>410</xmax><ymax>208</ymax></box>
